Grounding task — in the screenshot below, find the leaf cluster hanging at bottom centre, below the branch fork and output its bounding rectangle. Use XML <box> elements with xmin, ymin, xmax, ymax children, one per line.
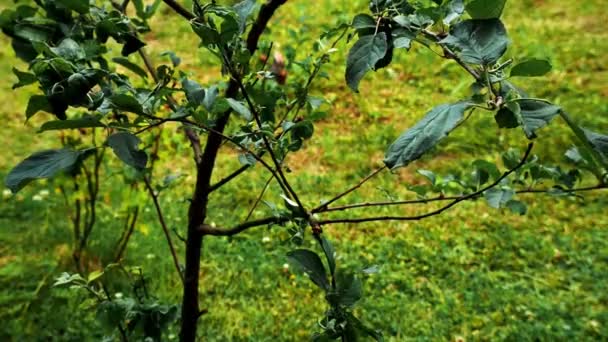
<box><xmin>288</xmin><ymin>236</ymin><xmax>382</xmax><ymax>341</ymax></box>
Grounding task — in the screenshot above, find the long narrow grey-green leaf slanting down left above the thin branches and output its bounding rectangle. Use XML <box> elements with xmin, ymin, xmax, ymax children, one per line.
<box><xmin>384</xmin><ymin>102</ymin><xmax>472</xmax><ymax>170</ymax></box>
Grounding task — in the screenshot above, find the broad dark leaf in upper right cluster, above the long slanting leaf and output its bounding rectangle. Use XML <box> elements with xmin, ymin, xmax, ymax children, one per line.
<box><xmin>440</xmin><ymin>19</ymin><xmax>509</xmax><ymax>65</ymax></box>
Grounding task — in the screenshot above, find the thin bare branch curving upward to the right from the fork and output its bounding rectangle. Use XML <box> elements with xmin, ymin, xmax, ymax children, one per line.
<box><xmin>318</xmin><ymin>143</ymin><xmax>534</xmax><ymax>225</ymax></box>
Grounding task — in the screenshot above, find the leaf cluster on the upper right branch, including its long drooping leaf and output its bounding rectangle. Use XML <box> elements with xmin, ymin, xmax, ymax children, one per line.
<box><xmin>346</xmin><ymin>0</ymin><xmax>608</xmax><ymax>182</ymax></box>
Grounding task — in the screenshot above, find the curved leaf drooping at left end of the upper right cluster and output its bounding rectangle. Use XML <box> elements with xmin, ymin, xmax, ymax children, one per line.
<box><xmin>346</xmin><ymin>32</ymin><xmax>388</xmax><ymax>92</ymax></box>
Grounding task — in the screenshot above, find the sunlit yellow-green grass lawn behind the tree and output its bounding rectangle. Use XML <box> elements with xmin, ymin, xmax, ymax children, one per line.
<box><xmin>0</xmin><ymin>0</ymin><xmax>608</xmax><ymax>341</ymax></box>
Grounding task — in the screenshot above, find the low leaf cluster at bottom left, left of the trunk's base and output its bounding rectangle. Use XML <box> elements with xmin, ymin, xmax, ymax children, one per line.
<box><xmin>53</xmin><ymin>264</ymin><xmax>179</xmax><ymax>341</ymax></box>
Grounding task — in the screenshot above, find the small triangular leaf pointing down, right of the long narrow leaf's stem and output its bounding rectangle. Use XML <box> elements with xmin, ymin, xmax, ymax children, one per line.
<box><xmin>514</xmin><ymin>99</ymin><xmax>561</xmax><ymax>139</ymax></box>
